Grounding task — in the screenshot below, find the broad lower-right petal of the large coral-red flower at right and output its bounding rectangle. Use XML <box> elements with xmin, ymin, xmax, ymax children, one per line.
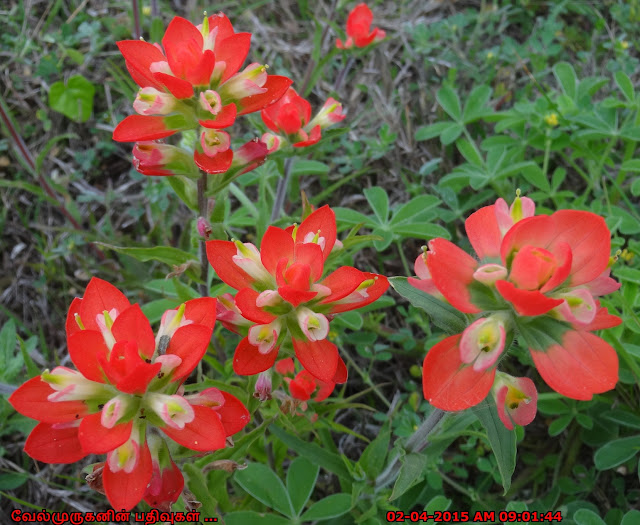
<box><xmin>529</xmin><ymin>330</ymin><xmax>618</xmax><ymax>401</ymax></box>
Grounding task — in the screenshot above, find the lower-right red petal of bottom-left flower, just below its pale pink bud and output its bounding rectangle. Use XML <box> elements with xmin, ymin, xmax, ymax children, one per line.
<box><xmin>162</xmin><ymin>405</ymin><xmax>226</xmax><ymax>452</ymax></box>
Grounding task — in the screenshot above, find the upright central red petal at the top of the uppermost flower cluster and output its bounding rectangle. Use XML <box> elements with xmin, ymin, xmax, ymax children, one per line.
<box><xmin>162</xmin><ymin>16</ymin><xmax>203</xmax><ymax>78</ymax></box>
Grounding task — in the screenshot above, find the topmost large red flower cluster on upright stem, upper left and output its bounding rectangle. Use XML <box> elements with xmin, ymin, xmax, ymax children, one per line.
<box><xmin>113</xmin><ymin>13</ymin><xmax>292</xmax><ymax>175</ymax></box>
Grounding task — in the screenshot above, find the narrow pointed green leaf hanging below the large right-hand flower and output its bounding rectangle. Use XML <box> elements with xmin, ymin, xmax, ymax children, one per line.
<box><xmin>471</xmin><ymin>396</ymin><xmax>516</xmax><ymax>494</ymax></box>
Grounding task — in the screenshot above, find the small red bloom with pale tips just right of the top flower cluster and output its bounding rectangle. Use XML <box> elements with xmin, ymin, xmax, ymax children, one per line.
<box><xmin>261</xmin><ymin>88</ymin><xmax>345</xmax><ymax>153</ymax></box>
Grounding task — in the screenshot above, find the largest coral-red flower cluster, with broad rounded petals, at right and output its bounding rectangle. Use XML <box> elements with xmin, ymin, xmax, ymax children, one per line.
<box><xmin>411</xmin><ymin>197</ymin><xmax>621</xmax><ymax>426</ymax></box>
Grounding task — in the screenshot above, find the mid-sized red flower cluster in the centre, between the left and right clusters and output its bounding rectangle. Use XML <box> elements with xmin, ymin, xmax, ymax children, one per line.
<box><xmin>207</xmin><ymin>206</ymin><xmax>389</xmax><ymax>383</ymax></box>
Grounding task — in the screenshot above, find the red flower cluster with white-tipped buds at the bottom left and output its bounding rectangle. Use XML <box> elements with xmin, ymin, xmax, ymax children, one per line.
<box><xmin>9</xmin><ymin>278</ymin><xmax>249</xmax><ymax>510</ymax></box>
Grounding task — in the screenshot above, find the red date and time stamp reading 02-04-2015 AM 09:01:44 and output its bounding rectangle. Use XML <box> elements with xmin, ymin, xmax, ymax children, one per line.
<box><xmin>387</xmin><ymin>510</ymin><xmax>562</xmax><ymax>523</ymax></box>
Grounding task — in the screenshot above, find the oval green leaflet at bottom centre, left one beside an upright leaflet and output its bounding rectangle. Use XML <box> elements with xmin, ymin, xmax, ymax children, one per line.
<box><xmin>234</xmin><ymin>463</ymin><xmax>297</xmax><ymax>518</ymax></box>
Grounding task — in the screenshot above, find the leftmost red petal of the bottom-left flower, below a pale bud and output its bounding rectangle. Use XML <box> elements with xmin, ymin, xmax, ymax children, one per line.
<box><xmin>9</xmin><ymin>376</ymin><xmax>89</xmax><ymax>423</ymax></box>
